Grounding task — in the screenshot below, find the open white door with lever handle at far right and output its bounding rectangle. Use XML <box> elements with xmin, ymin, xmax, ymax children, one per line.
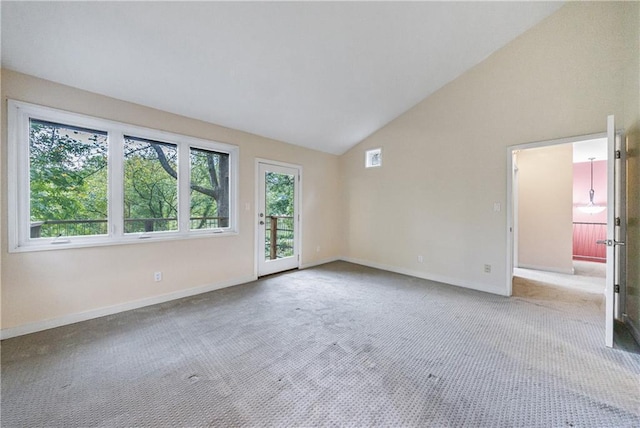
<box><xmin>598</xmin><ymin>116</ymin><xmax>626</xmax><ymax>347</ymax></box>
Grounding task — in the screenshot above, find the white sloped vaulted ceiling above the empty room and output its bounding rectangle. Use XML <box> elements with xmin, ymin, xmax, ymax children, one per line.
<box><xmin>1</xmin><ymin>1</ymin><xmax>562</xmax><ymax>154</ymax></box>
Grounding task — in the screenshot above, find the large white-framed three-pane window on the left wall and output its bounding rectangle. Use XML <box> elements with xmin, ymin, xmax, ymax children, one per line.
<box><xmin>8</xmin><ymin>100</ymin><xmax>238</xmax><ymax>251</ymax></box>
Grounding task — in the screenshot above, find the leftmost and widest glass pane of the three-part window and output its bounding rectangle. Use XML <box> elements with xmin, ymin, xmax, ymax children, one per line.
<box><xmin>29</xmin><ymin>119</ymin><xmax>108</xmax><ymax>238</ymax></box>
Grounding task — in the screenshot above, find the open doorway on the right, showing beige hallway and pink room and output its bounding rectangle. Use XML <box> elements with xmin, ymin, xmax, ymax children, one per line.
<box><xmin>513</xmin><ymin>138</ymin><xmax>607</xmax><ymax>280</ymax></box>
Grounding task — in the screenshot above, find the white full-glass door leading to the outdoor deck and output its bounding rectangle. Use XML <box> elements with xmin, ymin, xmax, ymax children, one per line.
<box><xmin>257</xmin><ymin>162</ymin><xmax>300</xmax><ymax>276</ymax></box>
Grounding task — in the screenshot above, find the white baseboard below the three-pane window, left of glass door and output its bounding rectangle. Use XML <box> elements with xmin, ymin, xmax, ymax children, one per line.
<box><xmin>0</xmin><ymin>276</ymin><xmax>257</xmax><ymax>340</ymax></box>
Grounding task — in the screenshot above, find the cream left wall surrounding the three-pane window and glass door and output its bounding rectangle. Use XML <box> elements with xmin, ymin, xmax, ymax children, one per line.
<box><xmin>0</xmin><ymin>70</ymin><xmax>342</xmax><ymax>337</ymax></box>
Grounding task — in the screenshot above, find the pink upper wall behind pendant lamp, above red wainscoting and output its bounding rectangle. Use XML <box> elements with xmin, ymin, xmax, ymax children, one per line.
<box><xmin>573</xmin><ymin>160</ymin><xmax>607</xmax><ymax>223</ymax></box>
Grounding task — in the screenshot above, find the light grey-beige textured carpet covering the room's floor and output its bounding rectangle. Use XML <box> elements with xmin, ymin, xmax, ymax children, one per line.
<box><xmin>1</xmin><ymin>262</ymin><xmax>640</xmax><ymax>427</ymax></box>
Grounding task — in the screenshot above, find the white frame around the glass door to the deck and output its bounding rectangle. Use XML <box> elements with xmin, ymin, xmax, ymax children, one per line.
<box><xmin>252</xmin><ymin>158</ymin><xmax>303</xmax><ymax>278</ymax></box>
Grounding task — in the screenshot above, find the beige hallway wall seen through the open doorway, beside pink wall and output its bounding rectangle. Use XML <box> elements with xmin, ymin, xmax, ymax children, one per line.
<box><xmin>516</xmin><ymin>144</ymin><xmax>573</xmax><ymax>274</ymax></box>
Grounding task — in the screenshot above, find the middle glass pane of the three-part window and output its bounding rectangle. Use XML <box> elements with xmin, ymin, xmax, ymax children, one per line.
<box><xmin>124</xmin><ymin>136</ymin><xmax>178</xmax><ymax>233</ymax></box>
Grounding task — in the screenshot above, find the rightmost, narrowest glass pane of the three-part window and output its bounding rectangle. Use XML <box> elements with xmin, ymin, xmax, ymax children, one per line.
<box><xmin>191</xmin><ymin>147</ymin><xmax>229</xmax><ymax>230</ymax></box>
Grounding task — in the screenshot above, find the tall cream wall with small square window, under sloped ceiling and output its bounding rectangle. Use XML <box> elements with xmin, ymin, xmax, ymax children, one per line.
<box><xmin>341</xmin><ymin>2</ymin><xmax>638</xmax><ymax>294</ymax></box>
